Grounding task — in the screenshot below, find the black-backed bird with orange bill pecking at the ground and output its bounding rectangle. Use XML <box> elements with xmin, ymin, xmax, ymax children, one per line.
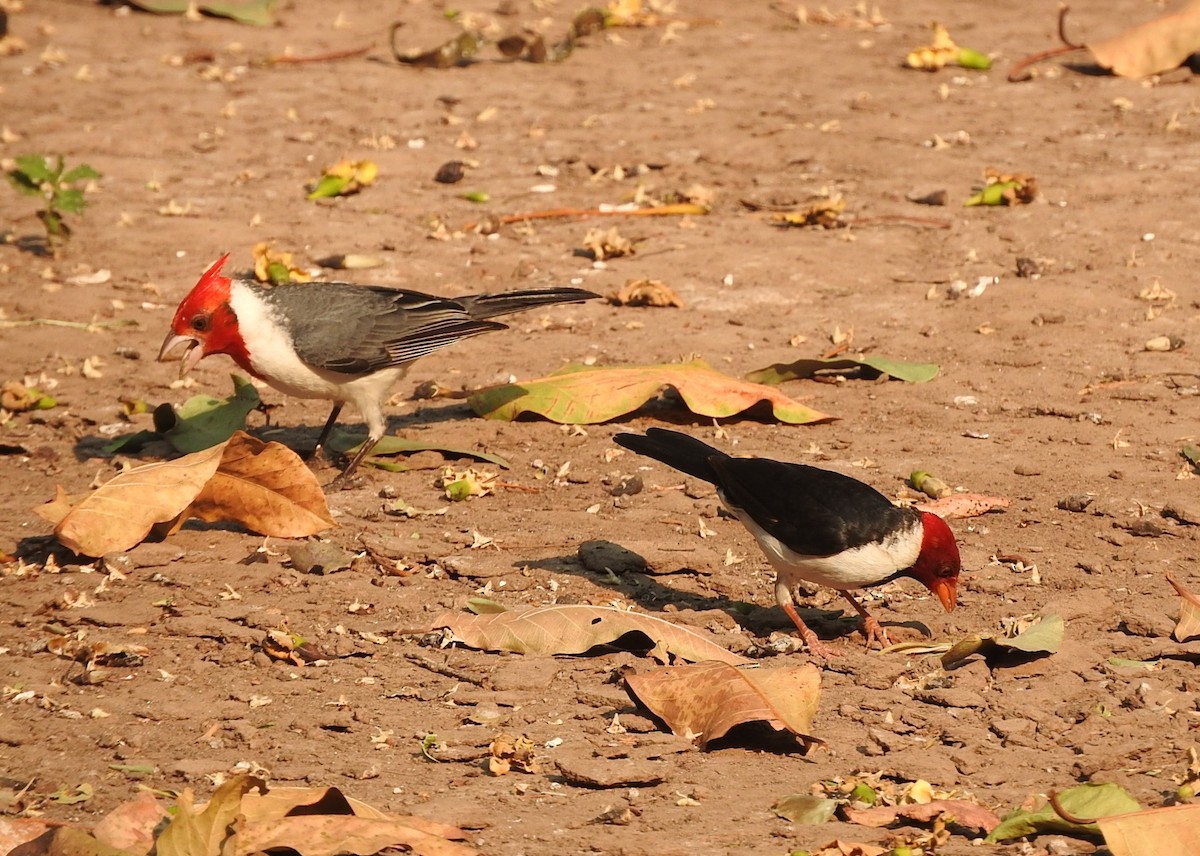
<box><xmin>613</xmin><ymin>429</ymin><xmax>962</xmax><ymax>654</ymax></box>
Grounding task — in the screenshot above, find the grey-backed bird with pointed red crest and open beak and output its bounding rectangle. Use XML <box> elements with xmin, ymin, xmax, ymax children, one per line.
<box><xmin>158</xmin><ymin>253</ymin><xmax>599</xmax><ymax>483</ymax></box>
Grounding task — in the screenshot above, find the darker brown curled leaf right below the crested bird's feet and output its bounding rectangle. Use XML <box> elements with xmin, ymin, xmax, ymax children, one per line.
<box><xmin>188</xmin><ymin>431</ymin><xmax>336</xmax><ymax>538</ymax></box>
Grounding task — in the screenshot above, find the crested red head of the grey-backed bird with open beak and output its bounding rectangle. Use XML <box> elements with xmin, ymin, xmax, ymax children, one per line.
<box><xmin>158</xmin><ymin>253</ymin><xmax>250</xmax><ymax>375</ymax></box>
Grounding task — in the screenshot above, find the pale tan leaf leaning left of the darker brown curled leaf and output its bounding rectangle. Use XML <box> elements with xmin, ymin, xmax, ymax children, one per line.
<box><xmin>37</xmin><ymin>444</ymin><xmax>224</xmax><ymax>556</ymax></box>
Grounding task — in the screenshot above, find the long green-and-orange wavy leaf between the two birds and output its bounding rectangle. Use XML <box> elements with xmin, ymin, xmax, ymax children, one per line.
<box><xmin>468</xmin><ymin>360</ymin><xmax>835</xmax><ymax>425</ymax></box>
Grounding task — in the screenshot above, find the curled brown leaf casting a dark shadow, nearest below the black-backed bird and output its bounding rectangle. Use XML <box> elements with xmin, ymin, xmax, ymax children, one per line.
<box><xmin>625</xmin><ymin>663</ymin><xmax>821</xmax><ymax>746</ymax></box>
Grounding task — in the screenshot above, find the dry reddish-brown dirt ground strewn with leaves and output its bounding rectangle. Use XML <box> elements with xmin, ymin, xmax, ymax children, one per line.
<box><xmin>0</xmin><ymin>0</ymin><xmax>1200</xmax><ymax>856</ymax></box>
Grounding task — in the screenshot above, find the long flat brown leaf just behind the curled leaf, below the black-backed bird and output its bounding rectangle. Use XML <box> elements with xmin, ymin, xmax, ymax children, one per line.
<box><xmin>433</xmin><ymin>604</ymin><xmax>749</xmax><ymax>664</ymax></box>
